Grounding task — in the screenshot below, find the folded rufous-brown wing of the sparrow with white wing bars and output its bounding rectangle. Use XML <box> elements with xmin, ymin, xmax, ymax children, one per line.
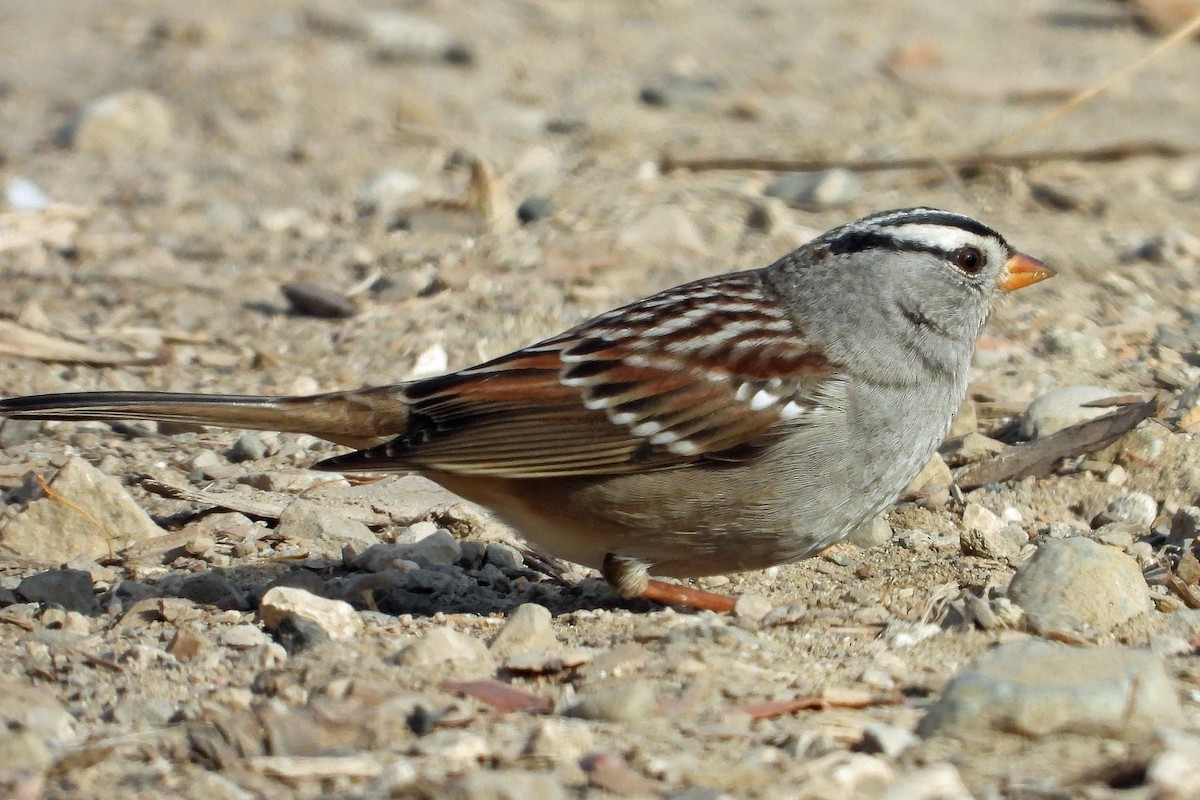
<box><xmin>323</xmin><ymin>272</ymin><xmax>832</xmax><ymax>477</ymax></box>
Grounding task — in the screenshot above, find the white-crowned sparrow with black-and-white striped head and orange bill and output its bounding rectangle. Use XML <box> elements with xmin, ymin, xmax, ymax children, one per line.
<box><xmin>0</xmin><ymin>207</ymin><xmax>1054</xmax><ymax>604</ymax></box>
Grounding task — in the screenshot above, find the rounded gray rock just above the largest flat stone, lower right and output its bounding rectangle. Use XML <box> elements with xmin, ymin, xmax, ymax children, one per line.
<box><xmin>1008</xmin><ymin>537</ymin><xmax>1151</xmax><ymax>633</ymax></box>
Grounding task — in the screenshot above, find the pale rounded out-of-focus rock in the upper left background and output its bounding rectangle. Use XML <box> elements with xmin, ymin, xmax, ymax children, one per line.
<box><xmin>65</xmin><ymin>89</ymin><xmax>173</xmax><ymax>156</ymax></box>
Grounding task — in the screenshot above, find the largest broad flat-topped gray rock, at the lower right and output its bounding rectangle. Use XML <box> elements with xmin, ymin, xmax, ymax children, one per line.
<box><xmin>917</xmin><ymin>638</ymin><xmax>1183</xmax><ymax>736</ymax></box>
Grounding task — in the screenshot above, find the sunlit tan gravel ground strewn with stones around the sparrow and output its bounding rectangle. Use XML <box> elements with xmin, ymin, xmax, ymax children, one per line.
<box><xmin>0</xmin><ymin>0</ymin><xmax>1200</xmax><ymax>800</ymax></box>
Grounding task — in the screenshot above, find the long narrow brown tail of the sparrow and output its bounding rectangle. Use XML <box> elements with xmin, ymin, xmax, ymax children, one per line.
<box><xmin>0</xmin><ymin>385</ymin><xmax>409</xmax><ymax>449</ymax></box>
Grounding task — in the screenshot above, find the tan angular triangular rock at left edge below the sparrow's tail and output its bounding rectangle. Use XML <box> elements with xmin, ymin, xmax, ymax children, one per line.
<box><xmin>0</xmin><ymin>457</ymin><xmax>167</xmax><ymax>564</ymax></box>
